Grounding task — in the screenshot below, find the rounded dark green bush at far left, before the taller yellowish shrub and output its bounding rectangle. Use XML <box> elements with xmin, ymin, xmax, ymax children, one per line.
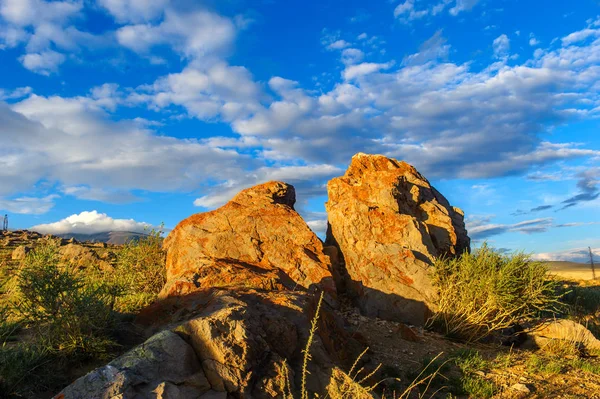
<box><xmin>16</xmin><ymin>245</ymin><xmax>119</xmax><ymax>356</ymax></box>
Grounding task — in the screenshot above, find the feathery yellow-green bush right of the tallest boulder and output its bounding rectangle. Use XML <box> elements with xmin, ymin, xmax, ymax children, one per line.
<box><xmin>428</xmin><ymin>244</ymin><xmax>559</xmax><ymax>341</ymax></box>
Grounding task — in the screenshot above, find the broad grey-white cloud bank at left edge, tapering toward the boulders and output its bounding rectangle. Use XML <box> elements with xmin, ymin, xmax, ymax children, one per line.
<box><xmin>0</xmin><ymin>95</ymin><xmax>255</xmax><ymax>198</ymax></box>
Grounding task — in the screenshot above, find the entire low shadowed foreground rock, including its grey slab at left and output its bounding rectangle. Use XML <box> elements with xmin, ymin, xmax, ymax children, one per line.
<box><xmin>57</xmin><ymin>288</ymin><xmax>362</xmax><ymax>399</ymax></box>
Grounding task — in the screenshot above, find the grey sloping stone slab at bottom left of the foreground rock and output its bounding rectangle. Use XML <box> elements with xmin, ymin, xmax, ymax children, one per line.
<box><xmin>55</xmin><ymin>330</ymin><xmax>211</xmax><ymax>399</ymax></box>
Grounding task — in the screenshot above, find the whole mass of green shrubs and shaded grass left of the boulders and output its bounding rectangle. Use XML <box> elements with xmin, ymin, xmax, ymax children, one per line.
<box><xmin>0</xmin><ymin>231</ymin><xmax>165</xmax><ymax>397</ymax></box>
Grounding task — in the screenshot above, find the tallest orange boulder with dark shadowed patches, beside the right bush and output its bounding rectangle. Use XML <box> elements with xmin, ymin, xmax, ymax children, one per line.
<box><xmin>326</xmin><ymin>153</ymin><xmax>470</xmax><ymax>325</ymax></box>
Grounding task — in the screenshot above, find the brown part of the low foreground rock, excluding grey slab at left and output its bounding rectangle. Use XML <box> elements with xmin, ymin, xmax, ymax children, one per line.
<box><xmin>137</xmin><ymin>287</ymin><xmax>364</xmax><ymax>399</ymax></box>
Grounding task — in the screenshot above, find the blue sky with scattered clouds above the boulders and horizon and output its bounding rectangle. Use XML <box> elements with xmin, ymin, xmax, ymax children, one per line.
<box><xmin>0</xmin><ymin>0</ymin><xmax>600</xmax><ymax>259</ymax></box>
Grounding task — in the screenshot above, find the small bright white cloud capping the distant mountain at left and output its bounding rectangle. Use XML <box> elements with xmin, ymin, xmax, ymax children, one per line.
<box><xmin>30</xmin><ymin>210</ymin><xmax>152</xmax><ymax>235</ymax></box>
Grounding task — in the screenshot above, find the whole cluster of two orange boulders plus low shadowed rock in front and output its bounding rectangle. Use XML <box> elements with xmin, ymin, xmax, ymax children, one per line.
<box><xmin>52</xmin><ymin>159</ymin><xmax>469</xmax><ymax>399</ymax></box>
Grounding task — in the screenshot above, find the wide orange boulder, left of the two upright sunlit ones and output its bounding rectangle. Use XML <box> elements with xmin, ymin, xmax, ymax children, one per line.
<box><xmin>160</xmin><ymin>182</ymin><xmax>336</xmax><ymax>302</ymax></box>
